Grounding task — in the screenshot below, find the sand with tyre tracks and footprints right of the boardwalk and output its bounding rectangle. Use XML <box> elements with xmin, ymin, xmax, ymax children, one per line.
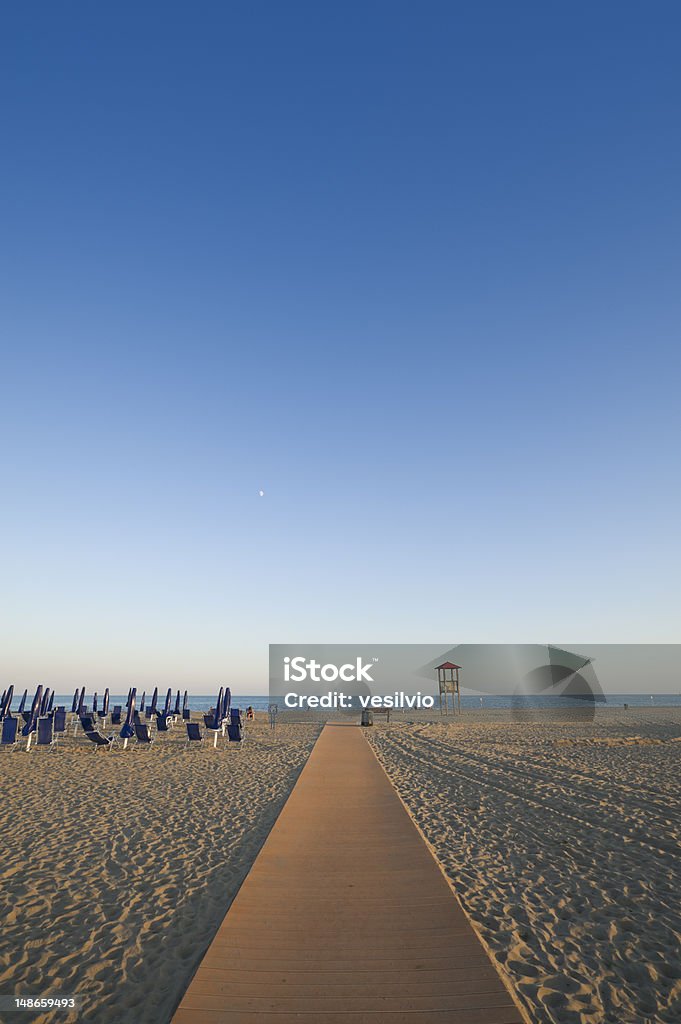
<box><xmin>370</xmin><ymin>708</ymin><xmax>681</xmax><ymax>1024</ymax></box>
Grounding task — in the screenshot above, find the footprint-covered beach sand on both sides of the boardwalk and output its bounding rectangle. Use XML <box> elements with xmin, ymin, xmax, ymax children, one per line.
<box><xmin>0</xmin><ymin>708</ymin><xmax>681</xmax><ymax>1024</ymax></box>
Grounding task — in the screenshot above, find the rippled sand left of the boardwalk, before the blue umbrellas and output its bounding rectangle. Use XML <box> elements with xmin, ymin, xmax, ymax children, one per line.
<box><xmin>0</xmin><ymin>715</ymin><xmax>320</xmax><ymax>1024</ymax></box>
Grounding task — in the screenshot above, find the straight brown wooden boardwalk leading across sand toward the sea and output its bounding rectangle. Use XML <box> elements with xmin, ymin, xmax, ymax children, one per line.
<box><xmin>173</xmin><ymin>725</ymin><xmax>522</xmax><ymax>1024</ymax></box>
